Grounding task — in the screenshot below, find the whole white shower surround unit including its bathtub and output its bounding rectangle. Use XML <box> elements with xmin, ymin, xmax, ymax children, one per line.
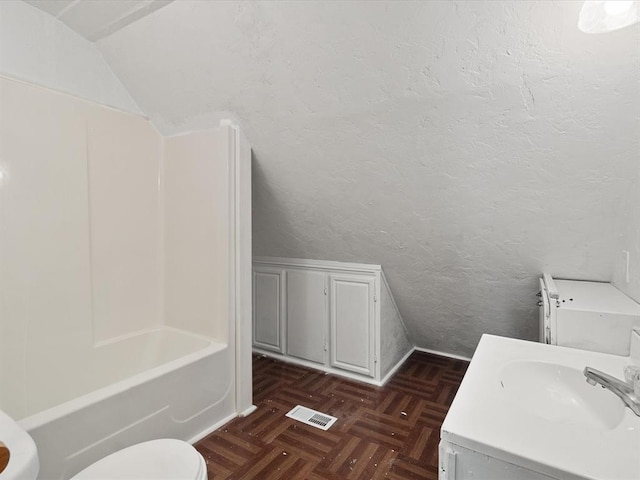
<box><xmin>0</xmin><ymin>78</ymin><xmax>252</xmax><ymax>479</ymax></box>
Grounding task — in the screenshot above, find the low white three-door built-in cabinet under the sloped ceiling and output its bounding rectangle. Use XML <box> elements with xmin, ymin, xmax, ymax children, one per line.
<box><xmin>253</xmin><ymin>257</ymin><xmax>410</xmax><ymax>383</ymax></box>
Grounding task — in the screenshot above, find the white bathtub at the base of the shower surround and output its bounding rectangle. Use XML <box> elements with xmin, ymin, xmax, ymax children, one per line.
<box><xmin>14</xmin><ymin>327</ymin><xmax>236</xmax><ymax>480</ymax></box>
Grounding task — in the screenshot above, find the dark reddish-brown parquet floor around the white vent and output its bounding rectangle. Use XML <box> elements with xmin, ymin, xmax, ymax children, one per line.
<box><xmin>196</xmin><ymin>352</ymin><xmax>468</xmax><ymax>480</ymax></box>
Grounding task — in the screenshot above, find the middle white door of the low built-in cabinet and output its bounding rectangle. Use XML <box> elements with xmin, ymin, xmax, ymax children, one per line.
<box><xmin>287</xmin><ymin>269</ymin><xmax>329</xmax><ymax>364</ymax></box>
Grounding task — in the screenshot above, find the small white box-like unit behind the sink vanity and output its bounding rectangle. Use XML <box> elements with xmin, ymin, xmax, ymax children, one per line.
<box><xmin>539</xmin><ymin>275</ymin><xmax>640</xmax><ymax>356</ymax></box>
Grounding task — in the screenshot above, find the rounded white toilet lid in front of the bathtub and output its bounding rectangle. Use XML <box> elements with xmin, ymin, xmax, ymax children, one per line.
<box><xmin>72</xmin><ymin>438</ymin><xmax>207</xmax><ymax>480</ymax></box>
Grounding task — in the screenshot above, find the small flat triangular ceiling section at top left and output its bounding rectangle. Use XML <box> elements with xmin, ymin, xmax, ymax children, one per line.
<box><xmin>24</xmin><ymin>0</ymin><xmax>173</xmax><ymax>41</ymax></box>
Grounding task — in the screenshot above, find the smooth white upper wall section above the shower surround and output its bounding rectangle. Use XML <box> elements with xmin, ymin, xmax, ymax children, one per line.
<box><xmin>0</xmin><ymin>0</ymin><xmax>140</xmax><ymax>113</ymax></box>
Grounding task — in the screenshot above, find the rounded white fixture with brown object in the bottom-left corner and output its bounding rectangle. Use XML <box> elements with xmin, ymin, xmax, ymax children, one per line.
<box><xmin>0</xmin><ymin>410</ymin><xmax>40</xmax><ymax>480</ymax></box>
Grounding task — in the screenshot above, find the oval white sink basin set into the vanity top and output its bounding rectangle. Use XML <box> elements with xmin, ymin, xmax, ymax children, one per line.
<box><xmin>498</xmin><ymin>361</ymin><xmax>625</xmax><ymax>430</ymax></box>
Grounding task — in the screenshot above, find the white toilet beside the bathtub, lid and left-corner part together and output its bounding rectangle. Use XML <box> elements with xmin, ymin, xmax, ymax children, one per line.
<box><xmin>0</xmin><ymin>410</ymin><xmax>207</xmax><ymax>480</ymax></box>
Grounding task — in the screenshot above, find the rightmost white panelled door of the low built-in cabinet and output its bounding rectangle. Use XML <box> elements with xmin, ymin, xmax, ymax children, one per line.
<box><xmin>331</xmin><ymin>275</ymin><xmax>375</xmax><ymax>376</ymax></box>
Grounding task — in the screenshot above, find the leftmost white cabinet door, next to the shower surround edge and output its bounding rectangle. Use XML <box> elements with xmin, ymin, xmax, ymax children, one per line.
<box><xmin>253</xmin><ymin>267</ymin><xmax>285</xmax><ymax>353</ymax></box>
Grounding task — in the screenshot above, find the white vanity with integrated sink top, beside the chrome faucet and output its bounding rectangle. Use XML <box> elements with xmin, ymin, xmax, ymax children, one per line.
<box><xmin>439</xmin><ymin>335</ymin><xmax>640</xmax><ymax>480</ymax></box>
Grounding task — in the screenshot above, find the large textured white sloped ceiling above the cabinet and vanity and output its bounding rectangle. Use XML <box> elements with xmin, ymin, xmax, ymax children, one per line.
<box><xmin>91</xmin><ymin>0</ymin><xmax>640</xmax><ymax>355</ymax></box>
